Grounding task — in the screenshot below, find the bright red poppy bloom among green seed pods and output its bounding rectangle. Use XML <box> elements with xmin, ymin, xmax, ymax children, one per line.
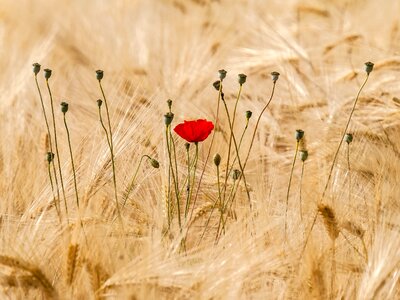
<box><xmin>174</xmin><ymin>119</ymin><xmax>214</xmax><ymax>143</ymax></box>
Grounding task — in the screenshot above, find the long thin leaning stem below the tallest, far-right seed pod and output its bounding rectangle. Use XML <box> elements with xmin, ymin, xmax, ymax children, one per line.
<box><xmin>301</xmin><ymin>73</ymin><xmax>369</xmax><ymax>256</ymax></box>
